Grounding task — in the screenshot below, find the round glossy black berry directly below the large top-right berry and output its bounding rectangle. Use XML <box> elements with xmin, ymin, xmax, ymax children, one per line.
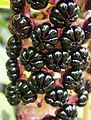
<box><xmin>59</xmin><ymin>26</ymin><xmax>85</xmax><ymax>51</ymax></box>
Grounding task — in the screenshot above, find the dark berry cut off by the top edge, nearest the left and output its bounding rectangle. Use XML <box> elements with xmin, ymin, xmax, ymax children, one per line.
<box><xmin>10</xmin><ymin>0</ymin><xmax>26</xmax><ymax>14</ymax></box>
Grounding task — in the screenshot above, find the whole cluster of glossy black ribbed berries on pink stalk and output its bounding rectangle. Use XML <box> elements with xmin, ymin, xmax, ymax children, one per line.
<box><xmin>5</xmin><ymin>0</ymin><xmax>91</xmax><ymax>120</ymax></box>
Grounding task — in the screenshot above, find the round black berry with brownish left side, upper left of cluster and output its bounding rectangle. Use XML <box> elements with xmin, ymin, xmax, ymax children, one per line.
<box><xmin>8</xmin><ymin>14</ymin><xmax>32</xmax><ymax>39</ymax></box>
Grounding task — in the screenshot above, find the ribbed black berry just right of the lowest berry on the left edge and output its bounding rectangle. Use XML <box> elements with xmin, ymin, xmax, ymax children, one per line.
<box><xmin>15</xmin><ymin>80</ymin><xmax>37</xmax><ymax>104</ymax></box>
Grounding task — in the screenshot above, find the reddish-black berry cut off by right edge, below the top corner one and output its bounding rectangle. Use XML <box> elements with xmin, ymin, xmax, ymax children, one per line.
<box><xmin>83</xmin><ymin>17</ymin><xmax>91</xmax><ymax>39</ymax></box>
